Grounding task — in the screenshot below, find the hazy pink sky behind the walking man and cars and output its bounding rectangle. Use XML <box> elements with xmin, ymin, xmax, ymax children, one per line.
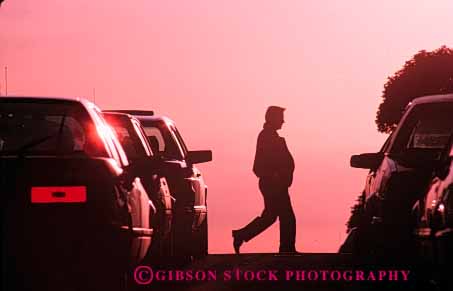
<box><xmin>0</xmin><ymin>0</ymin><xmax>453</xmax><ymax>253</ymax></box>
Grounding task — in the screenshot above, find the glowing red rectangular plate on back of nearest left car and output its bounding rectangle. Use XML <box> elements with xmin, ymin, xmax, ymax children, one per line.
<box><xmin>31</xmin><ymin>186</ymin><xmax>87</xmax><ymax>203</ymax></box>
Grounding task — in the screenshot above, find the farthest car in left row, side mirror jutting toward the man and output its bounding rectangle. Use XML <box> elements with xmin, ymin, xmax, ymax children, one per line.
<box><xmin>106</xmin><ymin>110</ymin><xmax>212</xmax><ymax>257</ymax></box>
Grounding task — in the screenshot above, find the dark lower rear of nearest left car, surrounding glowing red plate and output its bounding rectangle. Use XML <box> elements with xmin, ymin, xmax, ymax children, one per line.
<box><xmin>0</xmin><ymin>156</ymin><xmax>129</xmax><ymax>286</ymax></box>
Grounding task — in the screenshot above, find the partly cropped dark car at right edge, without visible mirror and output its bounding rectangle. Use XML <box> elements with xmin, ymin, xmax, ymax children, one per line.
<box><xmin>413</xmin><ymin>138</ymin><xmax>453</xmax><ymax>268</ymax></box>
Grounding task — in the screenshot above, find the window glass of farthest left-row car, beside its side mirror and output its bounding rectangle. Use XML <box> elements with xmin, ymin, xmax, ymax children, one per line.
<box><xmin>141</xmin><ymin>120</ymin><xmax>185</xmax><ymax>160</ymax></box>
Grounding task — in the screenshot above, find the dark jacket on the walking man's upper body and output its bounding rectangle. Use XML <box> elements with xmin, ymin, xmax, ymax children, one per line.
<box><xmin>253</xmin><ymin>124</ymin><xmax>294</xmax><ymax>187</ymax></box>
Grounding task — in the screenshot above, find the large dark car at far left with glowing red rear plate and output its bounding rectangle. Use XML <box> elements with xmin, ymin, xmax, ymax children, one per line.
<box><xmin>0</xmin><ymin>97</ymin><xmax>155</xmax><ymax>290</ymax></box>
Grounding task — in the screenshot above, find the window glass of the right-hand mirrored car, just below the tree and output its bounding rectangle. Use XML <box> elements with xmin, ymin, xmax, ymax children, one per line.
<box><xmin>391</xmin><ymin>103</ymin><xmax>453</xmax><ymax>153</ymax></box>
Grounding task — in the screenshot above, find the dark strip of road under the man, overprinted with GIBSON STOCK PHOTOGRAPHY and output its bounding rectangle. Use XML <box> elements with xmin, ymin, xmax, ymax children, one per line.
<box><xmin>131</xmin><ymin>254</ymin><xmax>438</xmax><ymax>291</ymax></box>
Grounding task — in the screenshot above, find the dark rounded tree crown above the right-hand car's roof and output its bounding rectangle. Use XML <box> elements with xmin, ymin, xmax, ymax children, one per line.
<box><xmin>376</xmin><ymin>46</ymin><xmax>453</xmax><ymax>133</ymax></box>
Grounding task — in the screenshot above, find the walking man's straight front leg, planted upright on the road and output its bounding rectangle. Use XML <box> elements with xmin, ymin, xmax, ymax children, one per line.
<box><xmin>278</xmin><ymin>189</ymin><xmax>296</xmax><ymax>252</ymax></box>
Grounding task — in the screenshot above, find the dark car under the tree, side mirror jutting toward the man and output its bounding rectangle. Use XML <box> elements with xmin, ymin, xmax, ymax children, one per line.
<box><xmin>340</xmin><ymin>94</ymin><xmax>453</xmax><ymax>257</ymax></box>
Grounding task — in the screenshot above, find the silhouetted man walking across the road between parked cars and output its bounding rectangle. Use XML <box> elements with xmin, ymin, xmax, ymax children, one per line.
<box><xmin>233</xmin><ymin>106</ymin><xmax>297</xmax><ymax>253</ymax></box>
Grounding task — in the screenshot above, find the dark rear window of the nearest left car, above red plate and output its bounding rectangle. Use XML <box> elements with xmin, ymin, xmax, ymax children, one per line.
<box><xmin>0</xmin><ymin>101</ymin><xmax>106</xmax><ymax>156</ymax></box>
